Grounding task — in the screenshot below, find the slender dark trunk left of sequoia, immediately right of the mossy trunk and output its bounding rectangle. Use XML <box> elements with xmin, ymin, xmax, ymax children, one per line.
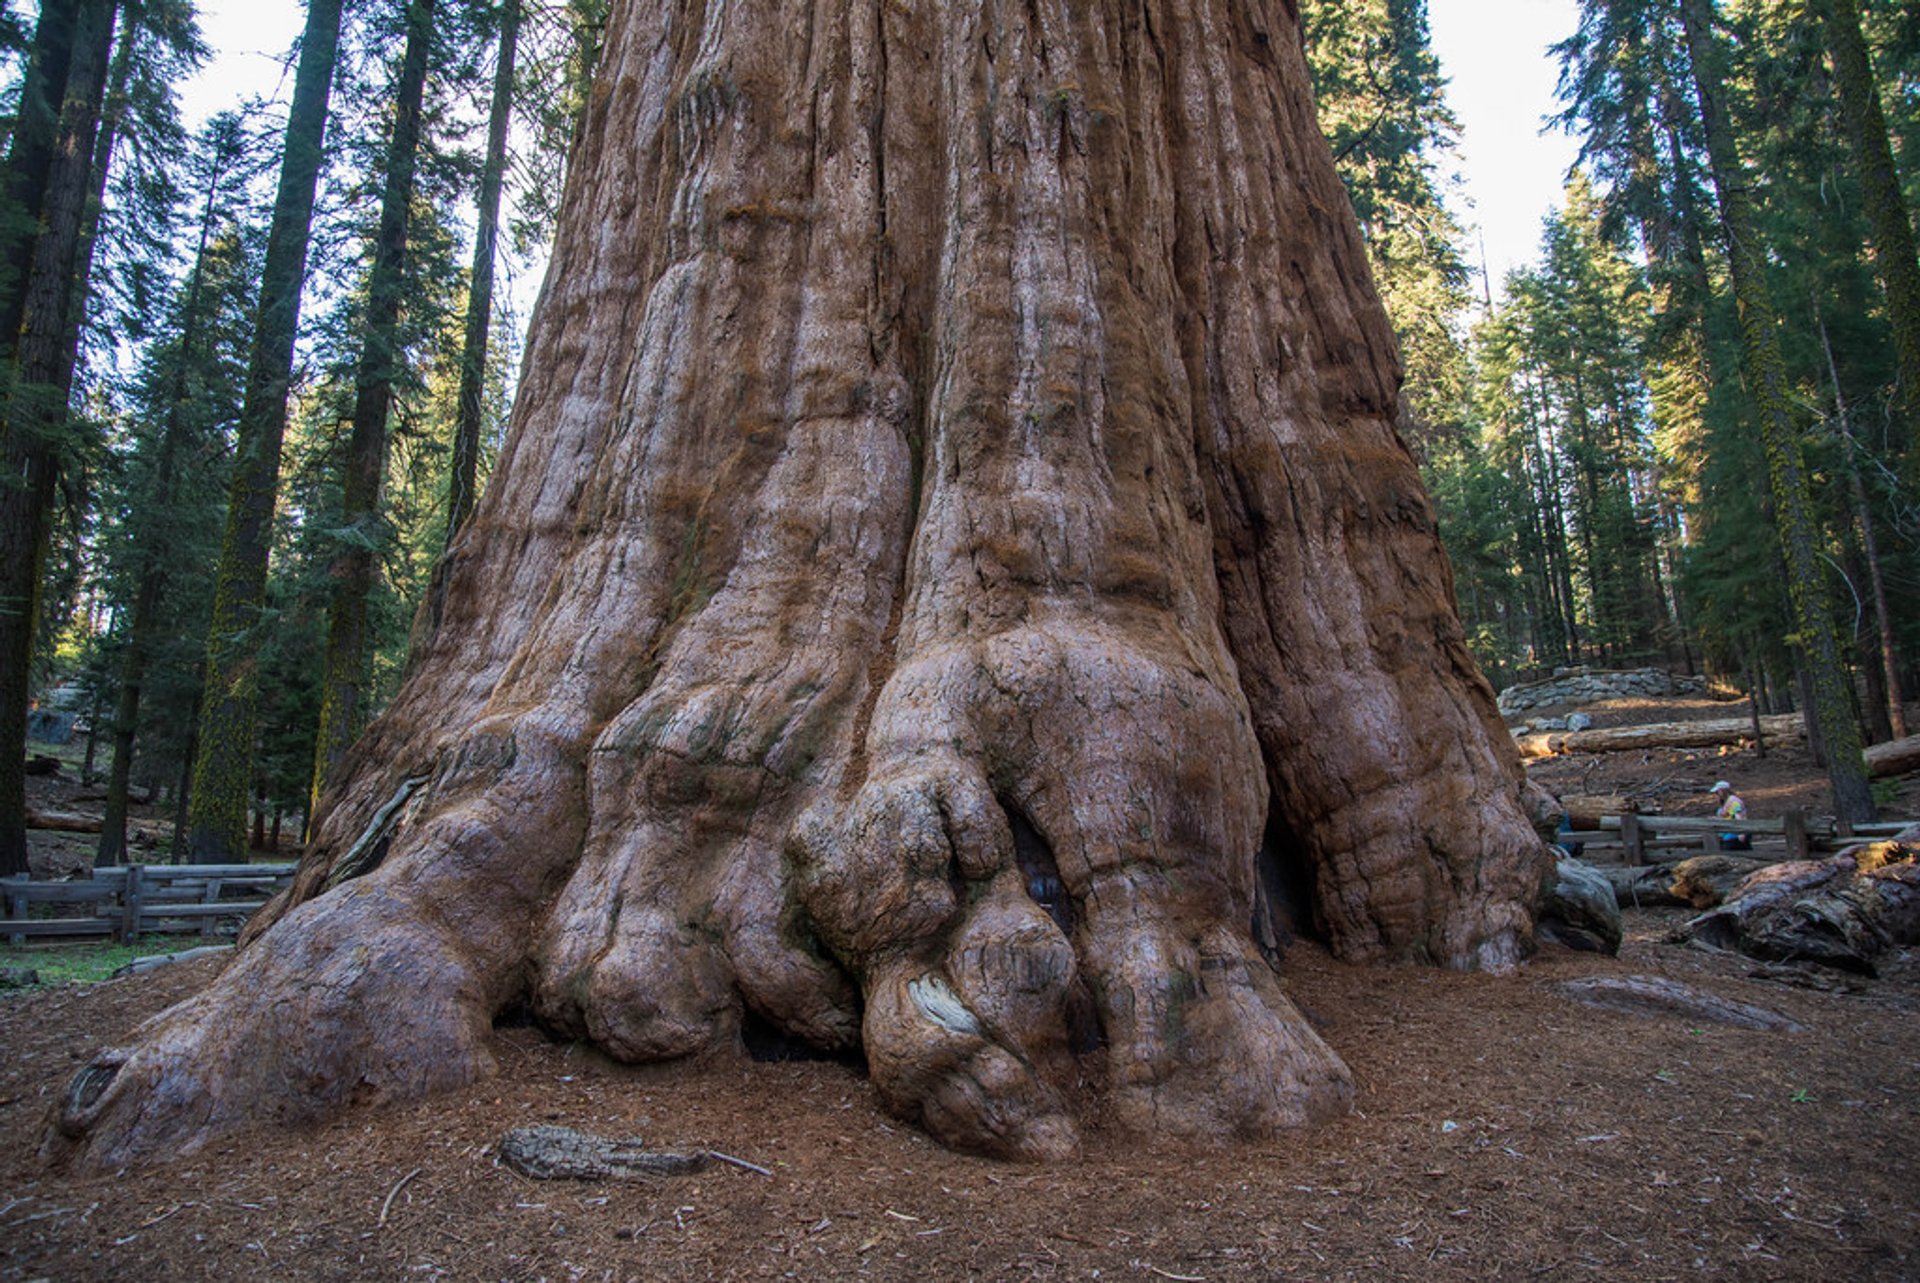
<box><xmin>311</xmin><ymin>0</ymin><xmax>434</xmax><ymax>803</ymax></box>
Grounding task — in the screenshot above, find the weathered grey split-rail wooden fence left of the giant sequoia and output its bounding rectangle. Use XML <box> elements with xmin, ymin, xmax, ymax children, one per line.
<box><xmin>0</xmin><ymin>864</ymin><xmax>298</xmax><ymax>945</ymax></box>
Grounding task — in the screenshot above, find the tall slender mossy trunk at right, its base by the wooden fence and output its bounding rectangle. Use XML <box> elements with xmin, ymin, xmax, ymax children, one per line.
<box><xmin>1680</xmin><ymin>0</ymin><xmax>1876</xmax><ymax>822</ymax></box>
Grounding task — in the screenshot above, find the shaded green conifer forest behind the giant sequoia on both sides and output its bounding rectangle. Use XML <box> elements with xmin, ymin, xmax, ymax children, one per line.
<box><xmin>0</xmin><ymin>0</ymin><xmax>1920</xmax><ymax>872</ymax></box>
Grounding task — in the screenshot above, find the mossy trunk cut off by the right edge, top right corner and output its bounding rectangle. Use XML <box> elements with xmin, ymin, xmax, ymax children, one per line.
<box><xmin>1818</xmin><ymin>0</ymin><xmax>1920</xmax><ymax>482</ymax></box>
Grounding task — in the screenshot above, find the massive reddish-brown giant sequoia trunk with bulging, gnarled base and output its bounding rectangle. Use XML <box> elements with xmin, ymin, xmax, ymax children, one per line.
<box><xmin>48</xmin><ymin>0</ymin><xmax>1546</xmax><ymax>1164</ymax></box>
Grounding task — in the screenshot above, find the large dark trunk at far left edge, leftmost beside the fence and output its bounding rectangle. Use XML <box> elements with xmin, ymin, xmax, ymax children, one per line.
<box><xmin>0</xmin><ymin>0</ymin><xmax>115</xmax><ymax>874</ymax></box>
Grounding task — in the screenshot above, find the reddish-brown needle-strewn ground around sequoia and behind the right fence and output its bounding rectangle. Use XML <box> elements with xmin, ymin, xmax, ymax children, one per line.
<box><xmin>0</xmin><ymin>701</ymin><xmax>1920</xmax><ymax>1283</ymax></box>
